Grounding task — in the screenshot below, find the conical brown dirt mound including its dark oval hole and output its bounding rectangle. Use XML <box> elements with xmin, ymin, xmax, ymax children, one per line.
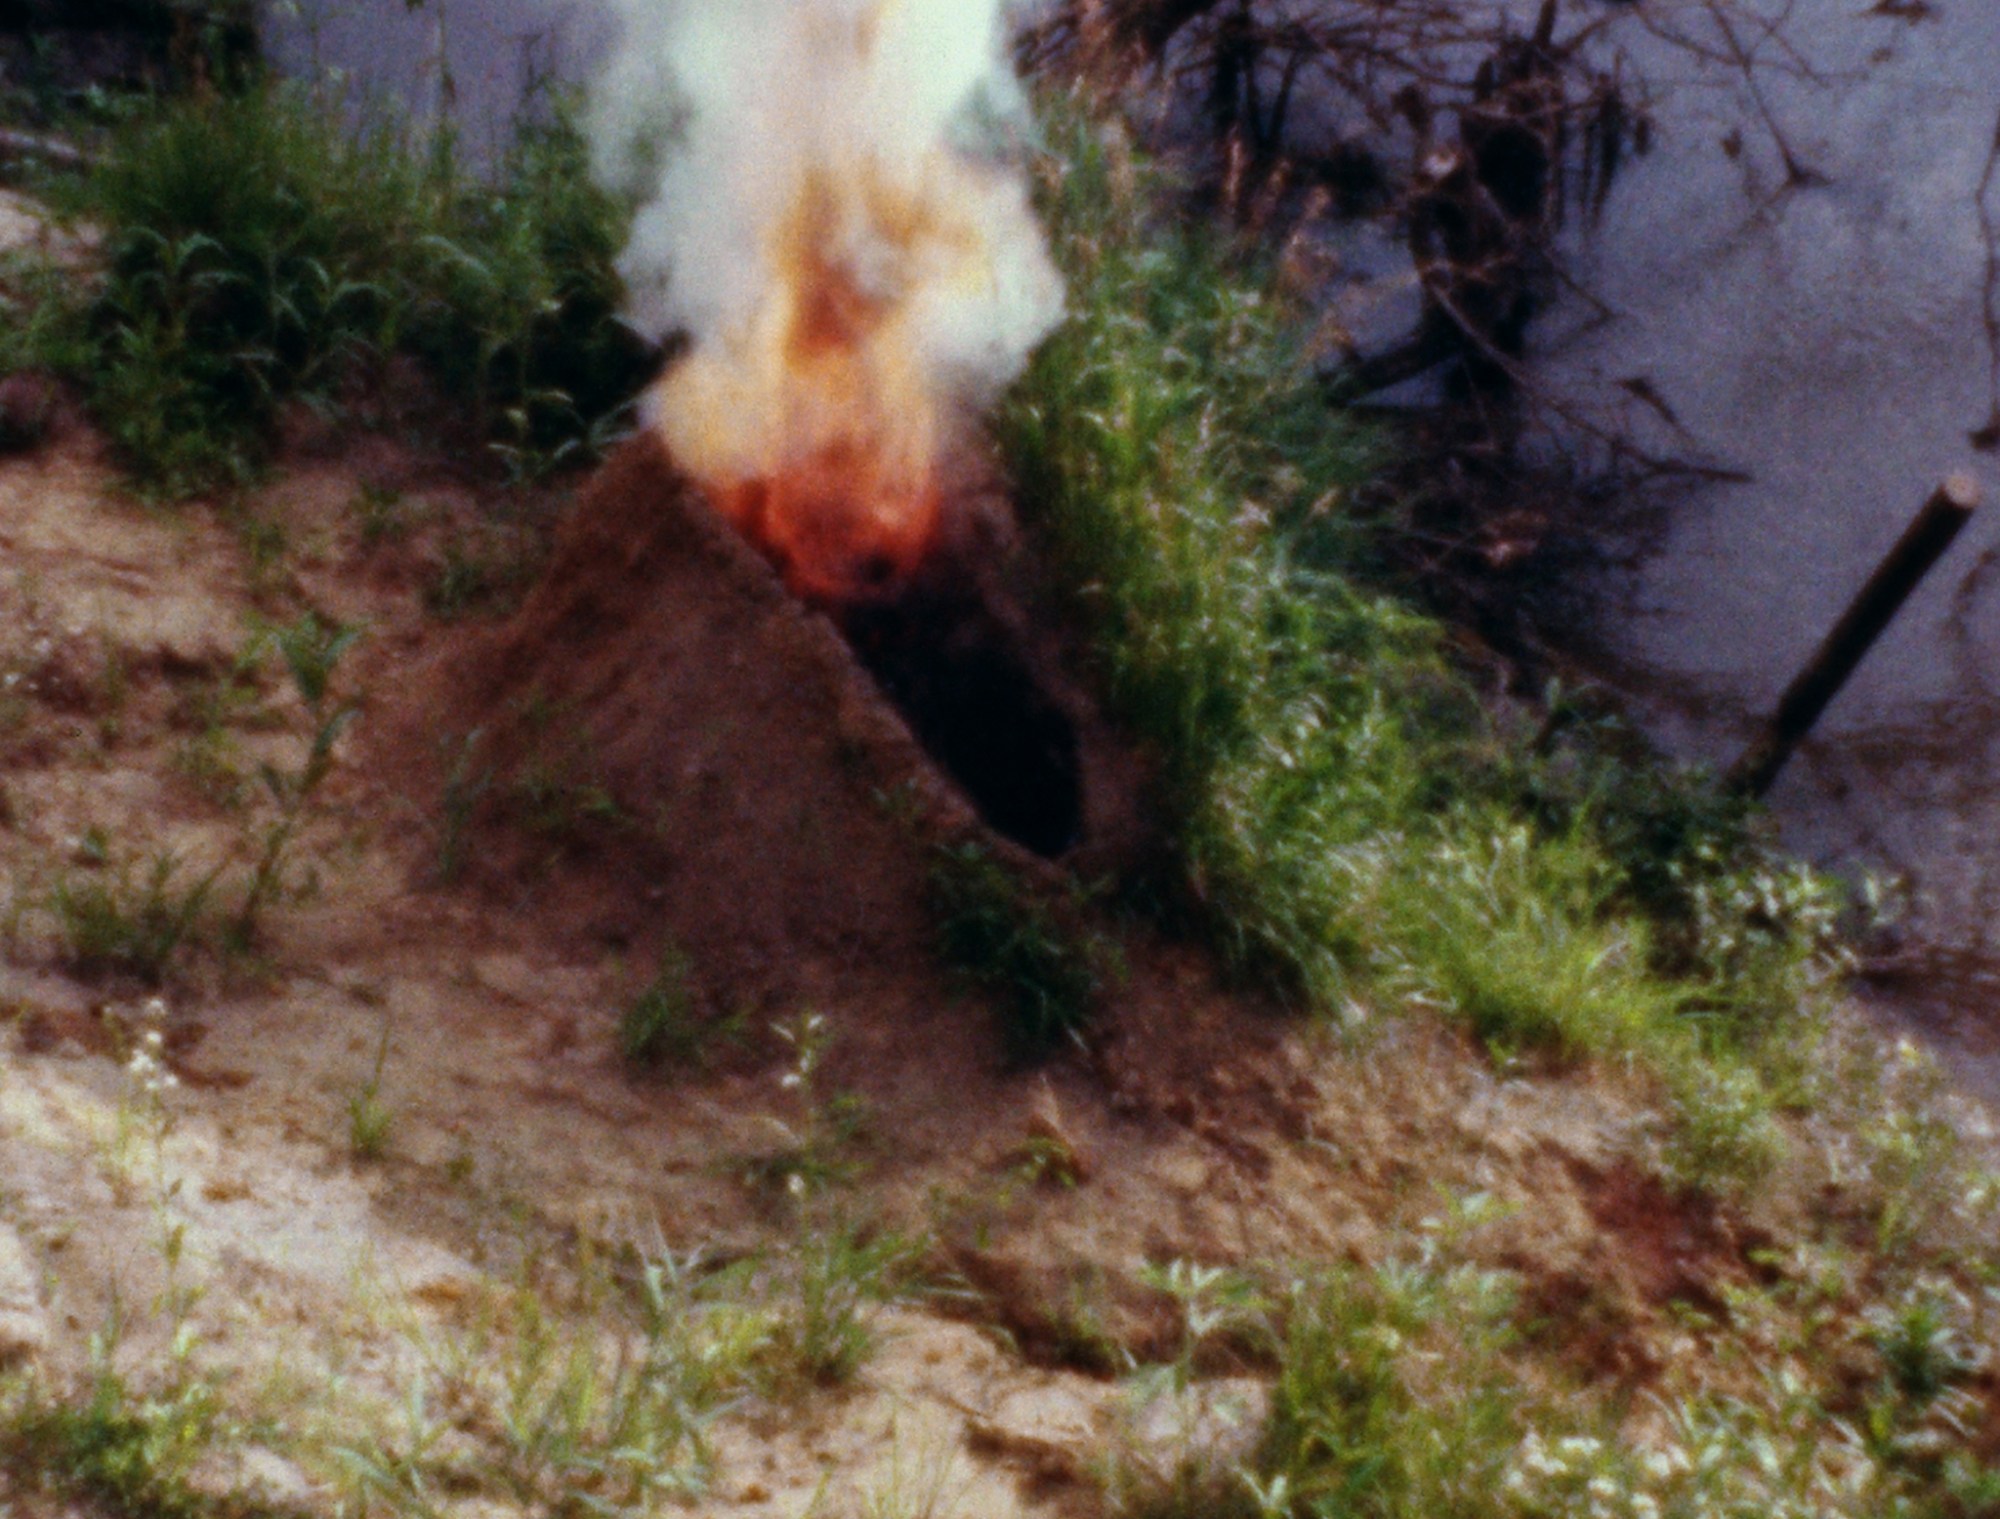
<box><xmin>386</xmin><ymin>440</ymin><xmax>1116</xmax><ymax>1005</ymax></box>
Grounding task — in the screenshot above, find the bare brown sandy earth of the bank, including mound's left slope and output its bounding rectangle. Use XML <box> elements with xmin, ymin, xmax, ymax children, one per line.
<box><xmin>0</xmin><ymin>409</ymin><xmax>1968</xmax><ymax>1515</ymax></box>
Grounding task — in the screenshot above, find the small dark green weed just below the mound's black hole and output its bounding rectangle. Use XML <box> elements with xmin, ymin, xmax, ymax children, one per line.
<box><xmin>930</xmin><ymin>841</ymin><xmax>1112</xmax><ymax>1059</ymax></box>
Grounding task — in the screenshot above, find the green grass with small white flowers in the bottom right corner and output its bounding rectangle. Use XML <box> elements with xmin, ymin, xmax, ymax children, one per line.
<box><xmin>1106</xmin><ymin>1195</ymin><xmax>2000</xmax><ymax>1519</ymax></box>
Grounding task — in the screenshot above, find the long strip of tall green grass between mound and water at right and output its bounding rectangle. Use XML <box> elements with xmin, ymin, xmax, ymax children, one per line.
<box><xmin>998</xmin><ymin>102</ymin><xmax>1836</xmax><ymax>1155</ymax></box>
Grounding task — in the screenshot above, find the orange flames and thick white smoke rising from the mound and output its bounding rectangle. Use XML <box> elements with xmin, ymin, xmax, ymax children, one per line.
<box><xmin>594</xmin><ymin>0</ymin><xmax>1062</xmax><ymax>596</ymax></box>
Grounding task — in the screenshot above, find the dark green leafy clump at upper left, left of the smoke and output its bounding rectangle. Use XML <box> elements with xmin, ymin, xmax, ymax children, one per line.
<box><xmin>6</xmin><ymin>82</ymin><xmax>646</xmax><ymax>498</ymax></box>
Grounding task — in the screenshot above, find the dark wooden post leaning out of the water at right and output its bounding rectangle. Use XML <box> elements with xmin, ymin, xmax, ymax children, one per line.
<box><xmin>1722</xmin><ymin>474</ymin><xmax>1980</xmax><ymax>795</ymax></box>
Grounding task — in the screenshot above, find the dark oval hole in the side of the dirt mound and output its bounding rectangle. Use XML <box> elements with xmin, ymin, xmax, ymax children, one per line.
<box><xmin>842</xmin><ymin>590</ymin><xmax>1084</xmax><ymax>859</ymax></box>
